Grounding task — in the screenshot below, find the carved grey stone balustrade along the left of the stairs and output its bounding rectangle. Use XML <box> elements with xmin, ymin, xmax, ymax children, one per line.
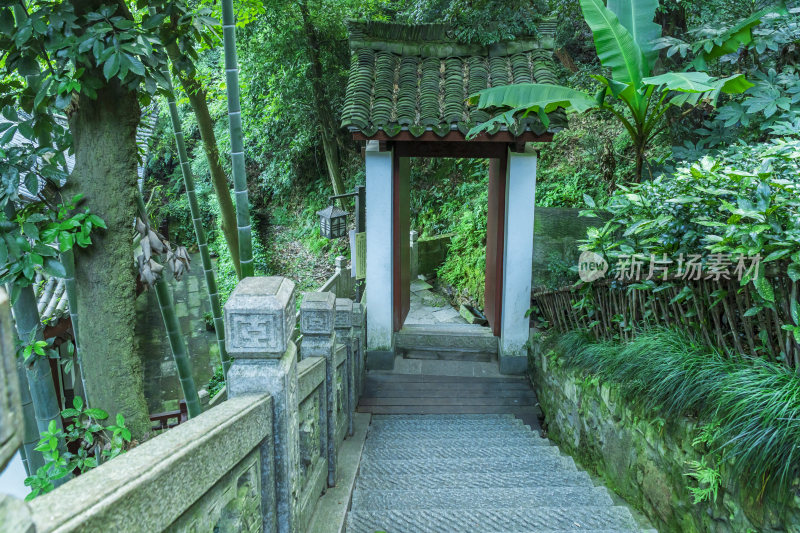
<box><xmin>0</xmin><ymin>277</ymin><xmax>364</xmax><ymax>533</ymax></box>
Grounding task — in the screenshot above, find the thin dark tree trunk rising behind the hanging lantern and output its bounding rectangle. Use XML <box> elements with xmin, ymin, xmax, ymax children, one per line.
<box><xmin>300</xmin><ymin>1</ymin><xmax>344</xmax><ymax>194</ymax></box>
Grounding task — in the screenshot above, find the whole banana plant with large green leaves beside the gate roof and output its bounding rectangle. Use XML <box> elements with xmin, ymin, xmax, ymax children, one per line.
<box><xmin>468</xmin><ymin>0</ymin><xmax>753</xmax><ymax>181</ymax></box>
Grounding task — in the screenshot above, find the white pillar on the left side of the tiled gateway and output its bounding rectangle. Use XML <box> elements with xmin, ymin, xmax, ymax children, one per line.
<box><xmin>365</xmin><ymin>141</ymin><xmax>394</xmax><ymax>369</ymax></box>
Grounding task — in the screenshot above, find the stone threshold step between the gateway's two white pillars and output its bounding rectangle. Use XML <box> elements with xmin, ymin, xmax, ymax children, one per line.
<box><xmin>395</xmin><ymin>324</ymin><xmax>497</xmax><ymax>354</ymax></box>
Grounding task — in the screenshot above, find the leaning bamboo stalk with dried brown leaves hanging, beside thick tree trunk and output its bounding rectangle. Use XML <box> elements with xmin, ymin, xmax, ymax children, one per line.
<box><xmin>136</xmin><ymin>194</ymin><xmax>203</xmax><ymax>418</ymax></box>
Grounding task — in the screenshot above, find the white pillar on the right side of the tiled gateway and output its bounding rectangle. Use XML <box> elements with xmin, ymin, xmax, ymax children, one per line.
<box><xmin>500</xmin><ymin>144</ymin><xmax>536</xmax><ymax>374</ymax></box>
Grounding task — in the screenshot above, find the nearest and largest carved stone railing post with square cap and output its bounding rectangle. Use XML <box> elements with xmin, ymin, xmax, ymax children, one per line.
<box><xmin>225</xmin><ymin>277</ymin><xmax>300</xmax><ymax>533</ymax></box>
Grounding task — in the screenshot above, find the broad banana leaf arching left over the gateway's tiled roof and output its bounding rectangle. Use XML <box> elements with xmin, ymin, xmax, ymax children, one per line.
<box><xmin>467</xmin><ymin>83</ymin><xmax>598</xmax><ymax>139</ymax></box>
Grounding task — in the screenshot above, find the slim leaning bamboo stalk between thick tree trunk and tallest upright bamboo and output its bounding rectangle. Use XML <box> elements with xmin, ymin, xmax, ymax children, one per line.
<box><xmin>164</xmin><ymin>72</ymin><xmax>231</xmax><ymax>380</ymax></box>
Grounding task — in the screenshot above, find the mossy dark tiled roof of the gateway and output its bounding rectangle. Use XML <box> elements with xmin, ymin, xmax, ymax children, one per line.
<box><xmin>342</xmin><ymin>22</ymin><xmax>566</xmax><ymax>137</ymax></box>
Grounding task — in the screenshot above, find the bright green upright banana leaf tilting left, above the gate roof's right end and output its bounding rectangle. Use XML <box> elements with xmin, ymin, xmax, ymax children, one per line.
<box><xmin>581</xmin><ymin>0</ymin><xmax>645</xmax><ymax>89</ymax></box>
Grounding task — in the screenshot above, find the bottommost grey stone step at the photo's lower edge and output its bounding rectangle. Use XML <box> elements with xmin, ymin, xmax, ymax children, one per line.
<box><xmin>347</xmin><ymin>506</ymin><xmax>638</xmax><ymax>533</ymax></box>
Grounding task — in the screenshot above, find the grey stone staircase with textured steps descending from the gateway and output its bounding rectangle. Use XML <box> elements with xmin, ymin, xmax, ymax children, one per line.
<box><xmin>346</xmin><ymin>414</ymin><xmax>656</xmax><ymax>533</ymax></box>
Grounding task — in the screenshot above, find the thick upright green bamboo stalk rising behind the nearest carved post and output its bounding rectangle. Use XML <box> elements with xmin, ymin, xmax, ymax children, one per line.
<box><xmin>222</xmin><ymin>0</ymin><xmax>253</xmax><ymax>279</ymax></box>
